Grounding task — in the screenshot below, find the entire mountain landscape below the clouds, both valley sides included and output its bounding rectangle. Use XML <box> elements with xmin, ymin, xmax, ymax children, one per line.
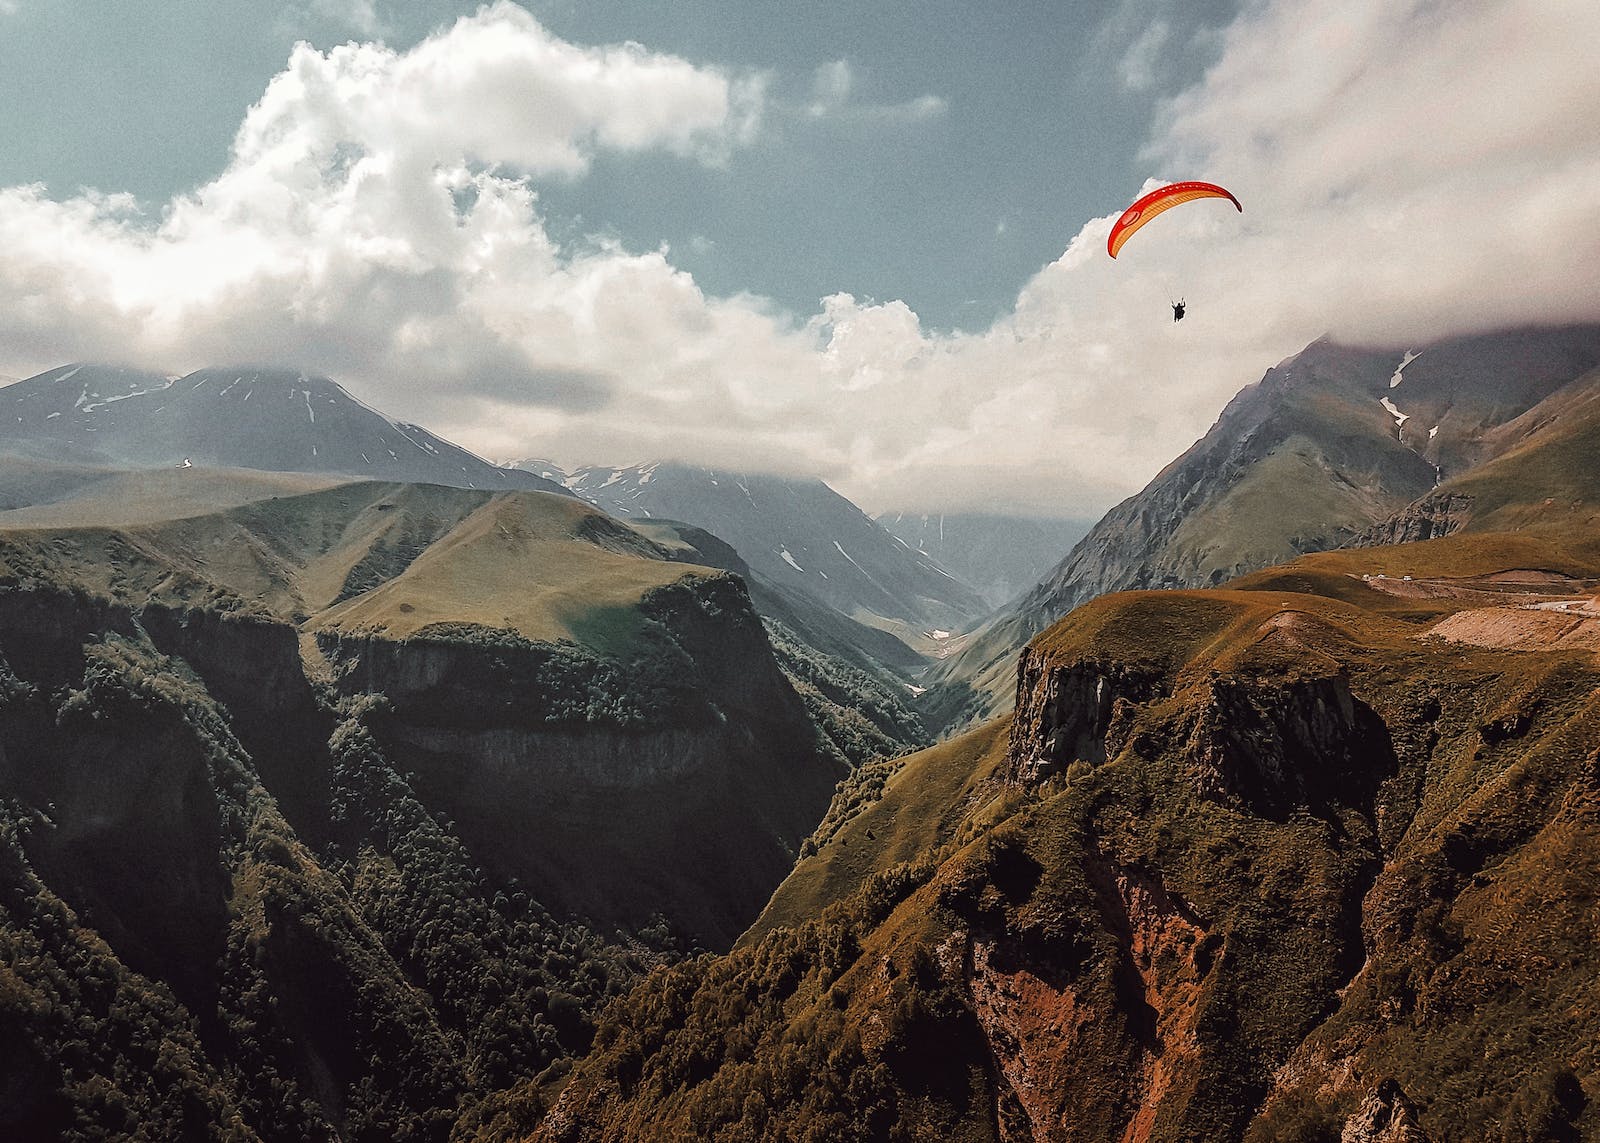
<box><xmin>0</xmin><ymin>327</ymin><xmax>1600</xmax><ymax>1143</ymax></box>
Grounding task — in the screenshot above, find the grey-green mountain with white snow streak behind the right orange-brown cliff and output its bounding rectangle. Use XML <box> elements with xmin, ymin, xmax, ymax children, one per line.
<box><xmin>930</xmin><ymin>327</ymin><xmax>1600</xmax><ymax>725</ymax></box>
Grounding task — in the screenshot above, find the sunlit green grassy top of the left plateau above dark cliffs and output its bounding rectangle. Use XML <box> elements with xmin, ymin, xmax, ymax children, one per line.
<box><xmin>0</xmin><ymin>483</ymin><xmax>707</xmax><ymax>645</ymax></box>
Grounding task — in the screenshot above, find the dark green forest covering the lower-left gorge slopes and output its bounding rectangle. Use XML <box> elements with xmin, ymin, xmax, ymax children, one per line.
<box><xmin>0</xmin><ymin>600</ymin><xmax>690</xmax><ymax>1140</ymax></box>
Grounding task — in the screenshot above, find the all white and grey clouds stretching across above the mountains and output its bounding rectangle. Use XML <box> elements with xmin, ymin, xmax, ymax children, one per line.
<box><xmin>0</xmin><ymin>0</ymin><xmax>1600</xmax><ymax>514</ymax></box>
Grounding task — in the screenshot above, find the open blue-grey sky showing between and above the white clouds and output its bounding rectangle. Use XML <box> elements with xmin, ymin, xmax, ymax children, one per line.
<box><xmin>0</xmin><ymin>0</ymin><xmax>1234</xmax><ymax>330</ymax></box>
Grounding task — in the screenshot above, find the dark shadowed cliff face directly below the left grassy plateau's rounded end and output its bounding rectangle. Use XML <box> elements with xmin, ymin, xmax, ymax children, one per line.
<box><xmin>318</xmin><ymin>576</ymin><xmax>843</xmax><ymax>944</ymax></box>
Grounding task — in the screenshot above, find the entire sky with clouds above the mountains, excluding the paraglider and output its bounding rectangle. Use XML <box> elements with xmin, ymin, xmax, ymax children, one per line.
<box><xmin>0</xmin><ymin>0</ymin><xmax>1600</xmax><ymax>515</ymax></box>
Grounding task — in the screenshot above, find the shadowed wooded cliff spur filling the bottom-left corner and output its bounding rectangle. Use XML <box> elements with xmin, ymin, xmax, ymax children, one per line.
<box><xmin>0</xmin><ymin>584</ymin><xmax>462</xmax><ymax>1138</ymax></box>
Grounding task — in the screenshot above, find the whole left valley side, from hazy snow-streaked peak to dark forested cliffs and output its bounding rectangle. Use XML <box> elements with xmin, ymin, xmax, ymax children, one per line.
<box><xmin>0</xmin><ymin>367</ymin><xmax>926</xmax><ymax>1138</ymax></box>
